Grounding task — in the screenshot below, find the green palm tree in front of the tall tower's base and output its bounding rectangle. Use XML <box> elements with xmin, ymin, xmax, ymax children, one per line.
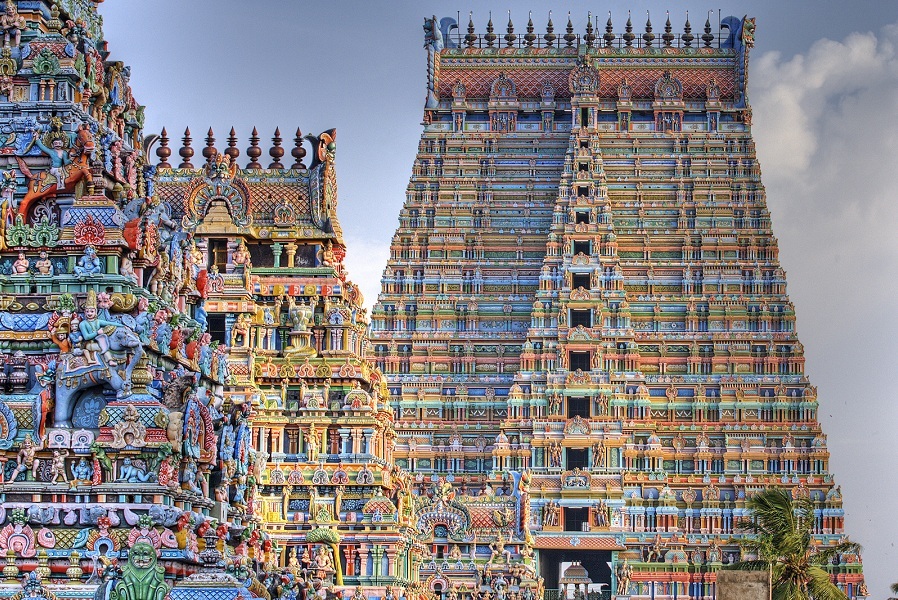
<box><xmin>728</xmin><ymin>488</ymin><xmax>860</xmax><ymax>600</ymax></box>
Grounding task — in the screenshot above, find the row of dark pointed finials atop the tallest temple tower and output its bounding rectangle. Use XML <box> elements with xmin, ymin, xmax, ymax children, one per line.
<box><xmin>457</xmin><ymin>11</ymin><xmax>721</xmax><ymax>48</ymax></box>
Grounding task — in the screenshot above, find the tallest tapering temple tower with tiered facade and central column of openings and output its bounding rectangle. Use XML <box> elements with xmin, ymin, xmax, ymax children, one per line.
<box><xmin>371</xmin><ymin>11</ymin><xmax>865</xmax><ymax>600</ymax></box>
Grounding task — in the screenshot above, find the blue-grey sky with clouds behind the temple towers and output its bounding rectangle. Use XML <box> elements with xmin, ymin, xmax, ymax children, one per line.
<box><xmin>100</xmin><ymin>0</ymin><xmax>898</xmax><ymax>598</ymax></box>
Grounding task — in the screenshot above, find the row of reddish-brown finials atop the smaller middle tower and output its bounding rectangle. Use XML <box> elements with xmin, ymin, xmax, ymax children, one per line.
<box><xmin>156</xmin><ymin>127</ymin><xmax>306</xmax><ymax>170</ymax></box>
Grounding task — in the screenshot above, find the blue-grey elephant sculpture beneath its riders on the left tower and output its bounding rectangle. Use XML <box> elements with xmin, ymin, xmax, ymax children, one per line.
<box><xmin>44</xmin><ymin>324</ymin><xmax>144</xmax><ymax>428</ymax></box>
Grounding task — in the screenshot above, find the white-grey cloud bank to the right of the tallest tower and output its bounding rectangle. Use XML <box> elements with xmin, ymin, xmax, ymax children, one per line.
<box><xmin>749</xmin><ymin>24</ymin><xmax>898</xmax><ymax>597</ymax></box>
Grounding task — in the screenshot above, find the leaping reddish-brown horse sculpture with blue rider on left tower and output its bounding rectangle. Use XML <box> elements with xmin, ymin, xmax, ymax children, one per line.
<box><xmin>16</xmin><ymin>125</ymin><xmax>96</xmax><ymax>218</ymax></box>
